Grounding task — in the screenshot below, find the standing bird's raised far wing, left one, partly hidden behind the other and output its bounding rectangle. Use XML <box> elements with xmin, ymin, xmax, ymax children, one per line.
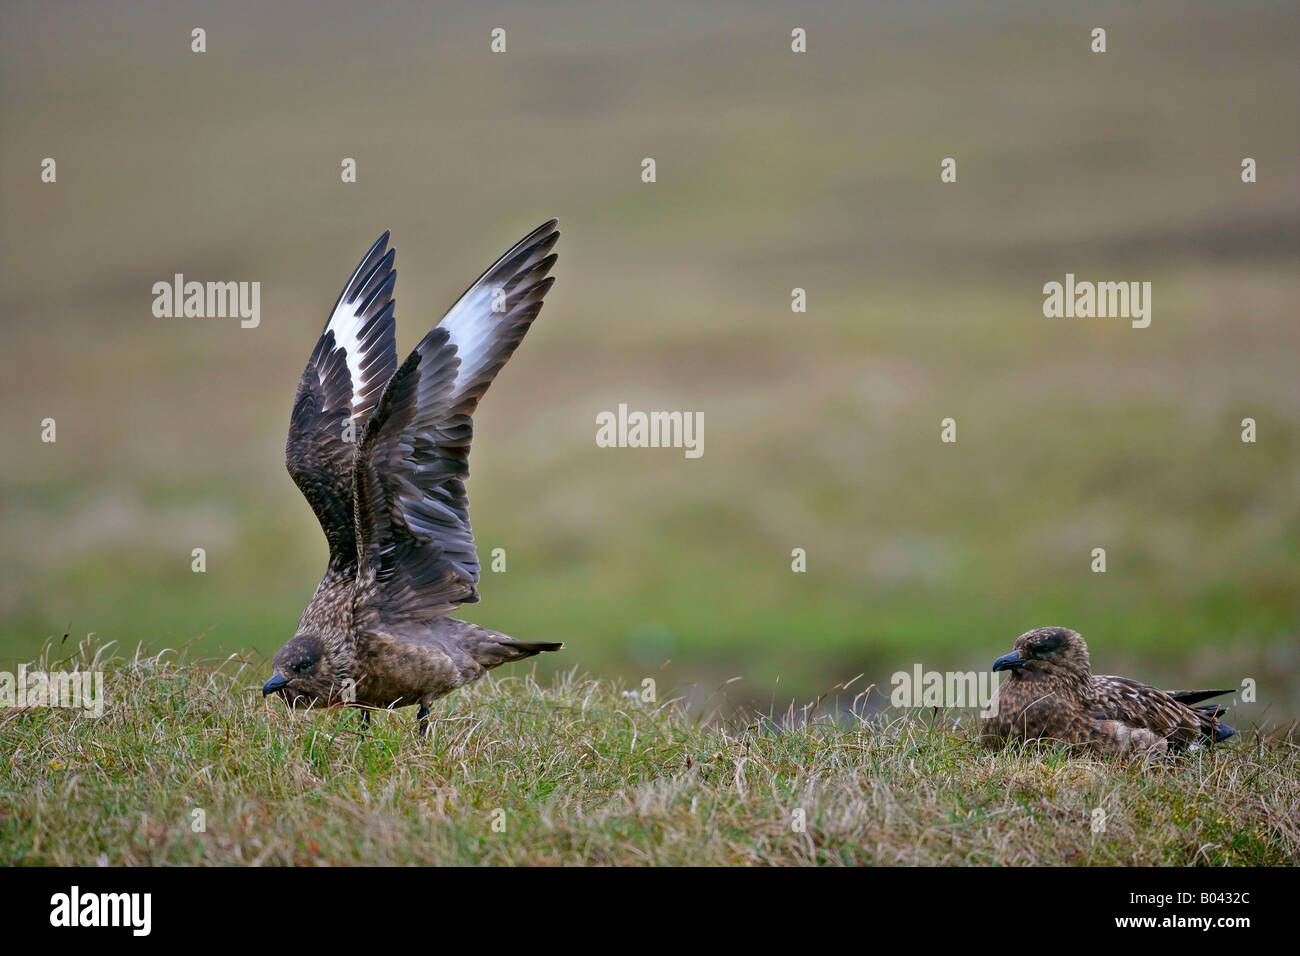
<box><xmin>285</xmin><ymin>233</ymin><xmax>398</xmax><ymax>571</ymax></box>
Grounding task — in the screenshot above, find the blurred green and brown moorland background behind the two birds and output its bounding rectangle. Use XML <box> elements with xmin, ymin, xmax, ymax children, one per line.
<box><xmin>0</xmin><ymin>3</ymin><xmax>1300</xmax><ymax>723</ymax></box>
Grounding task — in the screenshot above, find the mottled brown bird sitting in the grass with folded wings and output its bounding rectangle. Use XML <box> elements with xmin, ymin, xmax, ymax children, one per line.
<box><xmin>980</xmin><ymin>627</ymin><xmax>1236</xmax><ymax>754</ymax></box>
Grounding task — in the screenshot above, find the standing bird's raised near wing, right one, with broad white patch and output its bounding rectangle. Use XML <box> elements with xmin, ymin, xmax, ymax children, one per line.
<box><xmin>354</xmin><ymin>220</ymin><xmax>559</xmax><ymax>624</ymax></box>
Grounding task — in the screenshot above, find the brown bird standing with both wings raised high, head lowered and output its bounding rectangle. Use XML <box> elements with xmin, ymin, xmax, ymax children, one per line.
<box><xmin>263</xmin><ymin>220</ymin><xmax>562</xmax><ymax>735</ymax></box>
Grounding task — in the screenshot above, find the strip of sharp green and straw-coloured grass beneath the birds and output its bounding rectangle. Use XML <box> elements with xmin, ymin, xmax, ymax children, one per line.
<box><xmin>0</xmin><ymin>641</ymin><xmax>1300</xmax><ymax>865</ymax></box>
